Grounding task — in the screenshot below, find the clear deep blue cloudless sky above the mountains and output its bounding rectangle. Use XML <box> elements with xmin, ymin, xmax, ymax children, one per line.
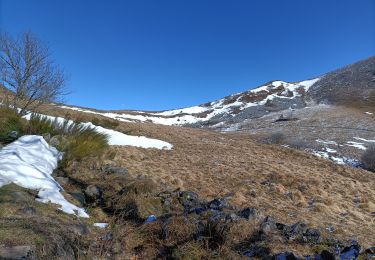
<box><xmin>0</xmin><ymin>0</ymin><xmax>375</xmax><ymax>110</ymax></box>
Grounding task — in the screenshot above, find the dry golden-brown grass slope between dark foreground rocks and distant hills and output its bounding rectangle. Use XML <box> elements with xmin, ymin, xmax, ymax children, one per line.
<box><xmin>43</xmin><ymin>104</ymin><xmax>375</xmax><ymax>247</ymax></box>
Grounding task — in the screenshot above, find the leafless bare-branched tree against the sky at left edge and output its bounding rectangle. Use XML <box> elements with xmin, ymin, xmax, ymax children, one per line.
<box><xmin>0</xmin><ymin>32</ymin><xmax>67</xmax><ymax>114</ymax></box>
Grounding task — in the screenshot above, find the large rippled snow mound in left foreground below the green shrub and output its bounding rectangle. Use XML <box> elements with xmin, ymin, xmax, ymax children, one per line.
<box><xmin>0</xmin><ymin>135</ymin><xmax>88</xmax><ymax>218</ymax></box>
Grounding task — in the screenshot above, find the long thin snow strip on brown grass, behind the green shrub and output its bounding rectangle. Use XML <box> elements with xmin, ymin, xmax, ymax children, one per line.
<box><xmin>24</xmin><ymin>113</ymin><xmax>173</xmax><ymax>150</ymax></box>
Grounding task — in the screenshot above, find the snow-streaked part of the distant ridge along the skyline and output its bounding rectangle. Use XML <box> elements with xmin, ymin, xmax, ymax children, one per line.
<box><xmin>61</xmin><ymin>78</ymin><xmax>319</xmax><ymax>125</ymax></box>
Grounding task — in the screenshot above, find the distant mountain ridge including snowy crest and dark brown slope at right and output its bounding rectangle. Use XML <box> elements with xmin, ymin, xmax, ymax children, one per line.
<box><xmin>60</xmin><ymin>57</ymin><xmax>375</xmax><ymax>130</ymax></box>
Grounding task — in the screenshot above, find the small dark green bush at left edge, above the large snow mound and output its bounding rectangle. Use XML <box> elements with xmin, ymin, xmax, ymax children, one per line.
<box><xmin>0</xmin><ymin>108</ymin><xmax>24</xmax><ymax>143</ymax></box>
